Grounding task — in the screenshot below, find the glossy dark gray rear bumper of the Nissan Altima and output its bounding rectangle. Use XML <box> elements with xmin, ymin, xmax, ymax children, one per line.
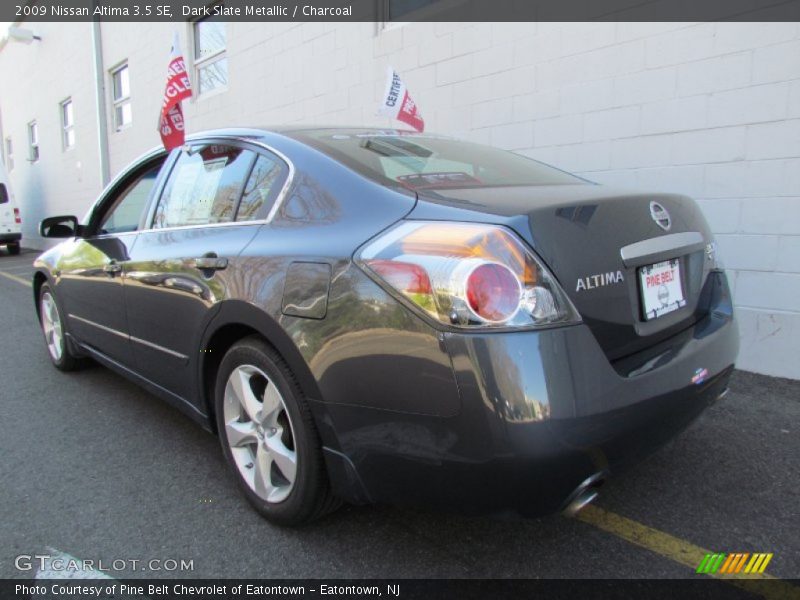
<box><xmin>318</xmin><ymin>274</ymin><xmax>738</xmax><ymax>515</ymax></box>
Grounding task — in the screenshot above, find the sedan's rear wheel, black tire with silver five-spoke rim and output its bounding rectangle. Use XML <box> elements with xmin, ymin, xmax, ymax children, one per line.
<box><xmin>214</xmin><ymin>336</ymin><xmax>340</xmax><ymax>525</ymax></box>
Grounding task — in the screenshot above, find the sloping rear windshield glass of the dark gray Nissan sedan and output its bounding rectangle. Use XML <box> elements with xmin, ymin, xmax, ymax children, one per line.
<box><xmin>294</xmin><ymin>130</ymin><xmax>585</xmax><ymax>191</ymax></box>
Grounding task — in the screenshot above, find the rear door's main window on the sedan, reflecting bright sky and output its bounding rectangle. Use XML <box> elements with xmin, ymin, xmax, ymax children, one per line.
<box><xmin>153</xmin><ymin>144</ymin><xmax>255</xmax><ymax>229</ymax></box>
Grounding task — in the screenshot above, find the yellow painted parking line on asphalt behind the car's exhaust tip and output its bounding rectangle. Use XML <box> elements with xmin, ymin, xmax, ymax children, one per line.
<box><xmin>576</xmin><ymin>505</ymin><xmax>800</xmax><ymax>600</ymax></box>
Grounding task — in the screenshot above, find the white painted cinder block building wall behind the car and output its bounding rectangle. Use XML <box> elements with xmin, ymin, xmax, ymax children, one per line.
<box><xmin>0</xmin><ymin>23</ymin><xmax>800</xmax><ymax>378</ymax></box>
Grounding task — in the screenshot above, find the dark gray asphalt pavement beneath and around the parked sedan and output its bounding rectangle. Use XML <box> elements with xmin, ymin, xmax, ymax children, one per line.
<box><xmin>0</xmin><ymin>250</ymin><xmax>800</xmax><ymax>579</ymax></box>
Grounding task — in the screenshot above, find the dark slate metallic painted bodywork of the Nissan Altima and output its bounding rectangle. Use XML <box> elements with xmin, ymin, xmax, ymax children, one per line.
<box><xmin>35</xmin><ymin>130</ymin><xmax>738</xmax><ymax>514</ymax></box>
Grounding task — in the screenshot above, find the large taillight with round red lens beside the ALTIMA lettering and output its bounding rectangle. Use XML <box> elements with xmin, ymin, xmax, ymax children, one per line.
<box><xmin>357</xmin><ymin>221</ymin><xmax>580</xmax><ymax>328</ymax></box>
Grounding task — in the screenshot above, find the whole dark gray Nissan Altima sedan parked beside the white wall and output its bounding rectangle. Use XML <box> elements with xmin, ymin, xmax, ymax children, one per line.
<box><xmin>33</xmin><ymin>128</ymin><xmax>738</xmax><ymax>524</ymax></box>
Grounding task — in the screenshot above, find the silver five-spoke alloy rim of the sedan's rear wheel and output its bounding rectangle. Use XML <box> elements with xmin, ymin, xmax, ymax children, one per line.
<box><xmin>223</xmin><ymin>365</ymin><xmax>297</xmax><ymax>503</ymax></box>
